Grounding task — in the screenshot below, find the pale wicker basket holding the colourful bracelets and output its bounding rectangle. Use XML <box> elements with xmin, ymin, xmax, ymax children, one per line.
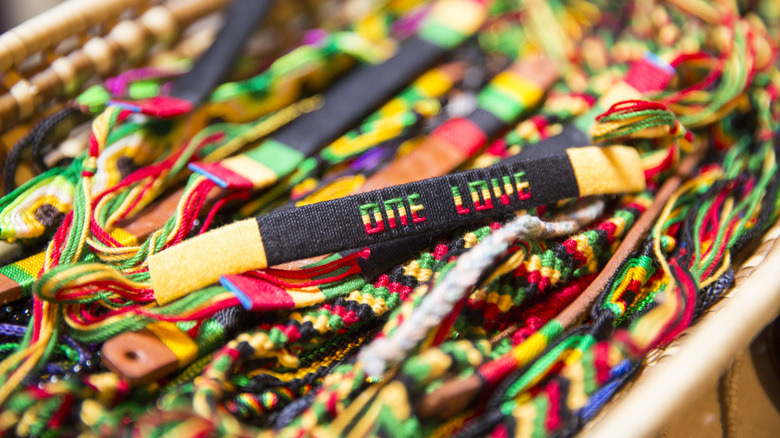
<box><xmin>0</xmin><ymin>0</ymin><xmax>780</xmax><ymax>437</ymax></box>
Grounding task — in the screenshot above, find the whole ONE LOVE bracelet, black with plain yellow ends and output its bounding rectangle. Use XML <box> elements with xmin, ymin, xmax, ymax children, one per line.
<box><xmin>149</xmin><ymin>146</ymin><xmax>645</xmax><ymax>304</ymax></box>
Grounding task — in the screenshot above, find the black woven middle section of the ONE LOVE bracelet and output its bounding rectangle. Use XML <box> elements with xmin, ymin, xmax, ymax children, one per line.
<box><xmin>257</xmin><ymin>151</ymin><xmax>579</xmax><ymax>265</ymax></box>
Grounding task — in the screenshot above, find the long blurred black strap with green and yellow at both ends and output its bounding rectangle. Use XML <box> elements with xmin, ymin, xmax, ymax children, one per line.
<box><xmin>190</xmin><ymin>0</ymin><xmax>487</xmax><ymax>189</ymax></box>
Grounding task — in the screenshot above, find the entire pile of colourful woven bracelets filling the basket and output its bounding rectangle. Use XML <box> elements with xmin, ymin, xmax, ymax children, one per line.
<box><xmin>0</xmin><ymin>0</ymin><xmax>780</xmax><ymax>438</ymax></box>
